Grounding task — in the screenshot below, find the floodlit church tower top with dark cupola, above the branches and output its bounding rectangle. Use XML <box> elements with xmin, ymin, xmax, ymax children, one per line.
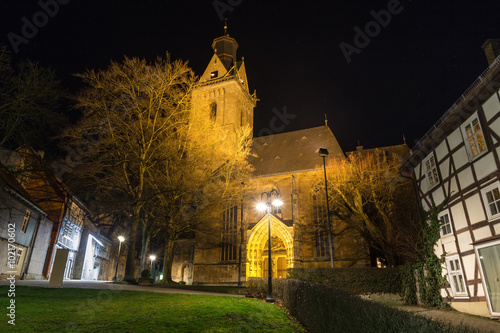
<box><xmin>189</xmin><ymin>25</ymin><xmax>257</xmax><ymax>135</ymax></box>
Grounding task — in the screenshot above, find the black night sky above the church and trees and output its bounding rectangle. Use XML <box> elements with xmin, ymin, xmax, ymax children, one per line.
<box><xmin>0</xmin><ymin>0</ymin><xmax>500</xmax><ymax>151</ymax></box>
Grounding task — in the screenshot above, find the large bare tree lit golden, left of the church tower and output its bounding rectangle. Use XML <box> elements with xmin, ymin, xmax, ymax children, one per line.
<box><xmin>61</xmin><ymin>54</ymin><xmax>195</xmax><ymax>281</ymax></box>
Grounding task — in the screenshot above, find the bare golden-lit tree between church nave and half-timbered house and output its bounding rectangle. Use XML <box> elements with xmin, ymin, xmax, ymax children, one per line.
<box><xmin>328</xmin><ymin>150</ymin><xmax>419</xmax><ymax>266</ymax></box>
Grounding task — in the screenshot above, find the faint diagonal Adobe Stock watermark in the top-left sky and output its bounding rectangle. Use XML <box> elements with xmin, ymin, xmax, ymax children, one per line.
<box><xmin>7</xmin><ymin>0</ymin><xmax>71</xmax><ymax>53</ymax></box>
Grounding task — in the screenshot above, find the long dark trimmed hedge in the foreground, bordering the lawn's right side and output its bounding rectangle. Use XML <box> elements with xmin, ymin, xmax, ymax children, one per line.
<box><xmin>247</xmin><ymin>278</ymin><xmax>473</xmax><ymax>333</ymax></box>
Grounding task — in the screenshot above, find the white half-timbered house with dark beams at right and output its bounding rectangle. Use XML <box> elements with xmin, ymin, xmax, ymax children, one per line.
<box><xmin>404</xmin><ymin>40</ymin><xmax>500</xmax><ymax>317</ymax></box>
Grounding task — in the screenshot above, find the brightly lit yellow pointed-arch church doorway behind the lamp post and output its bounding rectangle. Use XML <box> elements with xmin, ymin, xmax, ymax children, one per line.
<box><xmin>247</xmin><ymin>214</ymin><xmax>293</xmax><ymax>278</ymax></box>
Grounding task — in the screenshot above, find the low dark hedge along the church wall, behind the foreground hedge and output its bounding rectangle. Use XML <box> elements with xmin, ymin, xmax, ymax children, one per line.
<box><xmin>287</xmin><ymin>267</ymin><xmax>402</xmax><ymax>294</ymax></box>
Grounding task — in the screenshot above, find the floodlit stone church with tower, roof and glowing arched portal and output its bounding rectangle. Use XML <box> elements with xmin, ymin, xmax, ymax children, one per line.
<box><xmin>172</xmin><ymin>27</ymin><xmax>370</xmax><ymax>285</ymax></box>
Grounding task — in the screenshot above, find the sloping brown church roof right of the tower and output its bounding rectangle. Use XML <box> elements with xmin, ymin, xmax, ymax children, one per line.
<box><xmin>250</xmin><ymin>125</ymin><xmax>344</xmax><ymax>177</ymax></box>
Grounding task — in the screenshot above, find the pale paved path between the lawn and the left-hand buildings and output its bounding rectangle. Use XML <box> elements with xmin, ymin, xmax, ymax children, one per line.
<box><xmin>0</xmin><ymin>280</ymin><xmax>245</xmax><ymax>297</ymax></box>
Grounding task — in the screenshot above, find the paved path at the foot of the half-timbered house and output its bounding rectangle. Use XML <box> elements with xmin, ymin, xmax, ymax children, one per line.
<box><xmin>397</xmin><ymin>306</ymin><xmax>500</xmax><ymax>332</ymax></box>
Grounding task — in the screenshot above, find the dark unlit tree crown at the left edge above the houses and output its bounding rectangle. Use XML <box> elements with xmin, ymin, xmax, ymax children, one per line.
<box><xmin>0</xmin><ymin>46</ymin><xmax>65</xmax><ymax>149</ymax></box>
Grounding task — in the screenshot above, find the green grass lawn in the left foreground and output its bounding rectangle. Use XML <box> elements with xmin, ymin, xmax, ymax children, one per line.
<box><xmin>0</xmin><ymin>286</ymin><xmax>305</xmax><ymax>333</ymax></box>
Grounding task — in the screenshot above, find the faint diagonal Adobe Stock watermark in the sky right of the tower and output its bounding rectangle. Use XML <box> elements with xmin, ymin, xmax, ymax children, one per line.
<box><xmin>339</xmin><ymin>0</ymin><xmax>404</xmax><ymax>64</ymax></box>
